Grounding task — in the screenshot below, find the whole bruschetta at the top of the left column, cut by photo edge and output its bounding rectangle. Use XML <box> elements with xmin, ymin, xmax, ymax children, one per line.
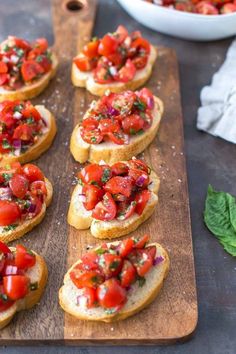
<box><xmin>0</xmin><ymin>36</ymin><xmax>58</xmax><ymax>102</ymax></box>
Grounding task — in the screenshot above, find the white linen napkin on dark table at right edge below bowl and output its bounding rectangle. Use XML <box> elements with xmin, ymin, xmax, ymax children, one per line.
<box><xmin>197</xmin><ymin>40</ymin><xmax>236</xmax><ymax>143</ymax></box>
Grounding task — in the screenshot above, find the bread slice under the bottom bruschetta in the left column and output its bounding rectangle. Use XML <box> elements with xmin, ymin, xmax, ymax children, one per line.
<box><xmin>0</xmin><ymin>247</ymin><xmax>48</xmax><ymax>329</ymax></box>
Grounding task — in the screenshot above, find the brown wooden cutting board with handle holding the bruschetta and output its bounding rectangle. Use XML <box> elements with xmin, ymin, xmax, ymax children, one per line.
<box><xmin>0</xmin><ymin>0</ymin><xmax>197</xmax><ymax>345</ymax></box>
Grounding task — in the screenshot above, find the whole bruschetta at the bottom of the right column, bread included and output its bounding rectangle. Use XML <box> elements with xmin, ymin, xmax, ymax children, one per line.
<box><xmin>59</xmin><ymin>235</ymin><xmax>170</xmax><ymax>322</ymax></box>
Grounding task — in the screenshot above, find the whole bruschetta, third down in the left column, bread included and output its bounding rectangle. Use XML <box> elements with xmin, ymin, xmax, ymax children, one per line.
<box><xmin>0</xmin><ymin>162</ymin><xmax>53</xmax><ymax>242</ymax></box>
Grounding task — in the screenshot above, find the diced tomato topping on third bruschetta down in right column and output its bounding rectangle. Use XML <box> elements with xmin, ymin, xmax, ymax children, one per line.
<box><xmin>78</xmin><ymin>158</ymin><xmax>151</xmax><ymax>221</ymax></box>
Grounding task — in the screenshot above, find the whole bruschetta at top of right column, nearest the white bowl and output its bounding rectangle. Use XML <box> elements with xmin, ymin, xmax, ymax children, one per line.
<box><xmin>72</xmin><ymin>26</ymin><xmax>157</xmax><ymax>96</ymax></box>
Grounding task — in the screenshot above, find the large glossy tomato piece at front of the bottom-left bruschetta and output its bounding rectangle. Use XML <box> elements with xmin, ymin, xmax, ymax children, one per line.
<box><xmin>3</xmin><ymin>275</ymin><xmax>30</xmax><ymax>300</ymax></box>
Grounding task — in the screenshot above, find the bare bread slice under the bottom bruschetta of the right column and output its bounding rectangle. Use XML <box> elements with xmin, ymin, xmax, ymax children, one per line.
<box><xmin>59</xmin><ymin>242</ymin><xmax>170</xmax><ymax>322</ymax></box>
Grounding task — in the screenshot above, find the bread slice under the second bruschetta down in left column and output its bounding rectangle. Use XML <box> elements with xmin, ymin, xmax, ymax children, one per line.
<box><xmin>0</xmin><ymin>105</ymin><xmax>57</xmax><ymax>167</ymax></box>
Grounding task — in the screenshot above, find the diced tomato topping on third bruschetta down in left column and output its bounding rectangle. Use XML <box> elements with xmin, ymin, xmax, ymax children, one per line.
<box><xmin>0</xmin><ymin>162</ymin><xmax>47</xmax><ymax>232</ymax></box>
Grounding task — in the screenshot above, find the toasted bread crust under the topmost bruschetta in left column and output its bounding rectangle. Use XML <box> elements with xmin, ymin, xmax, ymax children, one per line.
<box><xmin>0</xmin><ymin>53</ymin><xmax>58</xmax><ymax>102</ymax></box>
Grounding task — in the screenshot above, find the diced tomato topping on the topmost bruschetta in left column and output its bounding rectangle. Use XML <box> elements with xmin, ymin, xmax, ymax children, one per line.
<box><xmin>0</xmin><ymin>36</ymin><xmax>52</xmax><ymax>90</ymax></box>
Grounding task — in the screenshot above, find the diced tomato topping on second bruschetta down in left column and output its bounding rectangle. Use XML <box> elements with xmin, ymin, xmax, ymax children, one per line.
<box><xmin>0</xmin><ymin>101</ymin><xmax>48</xmax><ymax>156</ymax></box>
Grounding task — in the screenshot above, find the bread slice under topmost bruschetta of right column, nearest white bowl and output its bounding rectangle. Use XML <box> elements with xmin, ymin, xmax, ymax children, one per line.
<box><xmin>71</xmin><ymin>45</ymin><xmax>157</xmax><ymax>96</ymax></box>
